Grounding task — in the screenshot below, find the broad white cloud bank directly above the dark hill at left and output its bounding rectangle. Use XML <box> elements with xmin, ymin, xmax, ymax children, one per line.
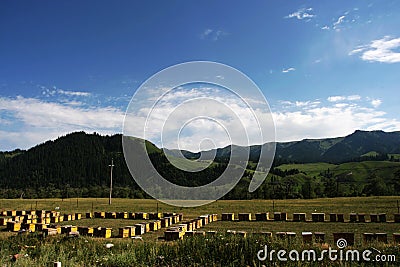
<box><xmin>0</xmin><ymin>96</ymin><xmax>124</xmax><ymax>150</ymax></box>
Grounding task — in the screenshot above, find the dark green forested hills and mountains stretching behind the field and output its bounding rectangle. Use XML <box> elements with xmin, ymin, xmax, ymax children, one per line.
<box><xmin>0</xmin><ymin>131</ymin><xmax>400</xmax><ymax>198</ymax></box>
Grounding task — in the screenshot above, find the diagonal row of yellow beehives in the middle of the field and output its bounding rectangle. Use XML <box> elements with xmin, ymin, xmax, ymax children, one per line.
<box><xmin>164</xmin><ymin>214</ymin><xmax>218</xmax><ymax>241</ymax></box>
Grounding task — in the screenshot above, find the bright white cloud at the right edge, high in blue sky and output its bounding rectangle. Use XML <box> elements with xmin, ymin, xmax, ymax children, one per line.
<box><xmin>349</xmin><ymin>36</ymin><xmax>400</xmax><ymax>63</ymax></box>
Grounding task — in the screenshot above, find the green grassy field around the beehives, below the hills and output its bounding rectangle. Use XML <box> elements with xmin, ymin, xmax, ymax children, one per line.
<box><xmin>0</xmin><ymin>197</ymin><xmax>400</xmax><ymax>266</ymax></box>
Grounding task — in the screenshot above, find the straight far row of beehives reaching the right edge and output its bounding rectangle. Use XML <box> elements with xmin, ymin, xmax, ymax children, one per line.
<box><xmin>221</xmin><ymin>212</ymin><xmax>400</xmax><ymax>223</ymax></box>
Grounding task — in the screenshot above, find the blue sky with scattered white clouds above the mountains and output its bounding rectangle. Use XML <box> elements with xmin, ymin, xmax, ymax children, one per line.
<box><xmin>0</xmin><ymin>0</ymin><xmax>400</xmax><ymax>151</ymax></box>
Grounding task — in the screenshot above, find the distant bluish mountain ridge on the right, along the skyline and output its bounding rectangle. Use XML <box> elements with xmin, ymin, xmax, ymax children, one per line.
<box><xmin>164</xmin><ymin>130</ymin><xmax>400</xmax><ymax>163</ymax></box>
